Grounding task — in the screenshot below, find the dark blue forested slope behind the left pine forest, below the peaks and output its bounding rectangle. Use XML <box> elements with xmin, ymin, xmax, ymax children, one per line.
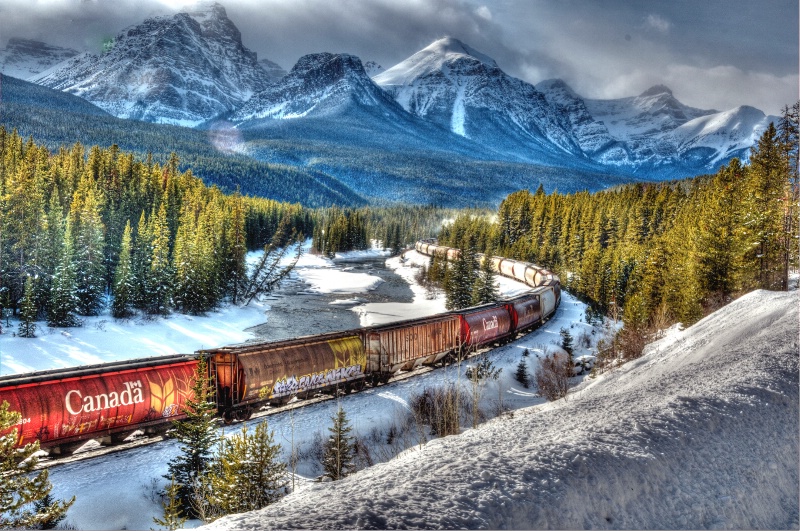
<box><xmin>0</xmin><ymin>76</ymin><xmax>366</xmax><ymax>207</ymax></box>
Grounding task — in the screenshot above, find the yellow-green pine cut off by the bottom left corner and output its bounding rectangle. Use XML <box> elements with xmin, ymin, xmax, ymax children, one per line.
<box><xmin>0</xmin><ymin>400</ymin><xmax>75</xmax><ymax>529</ymax></box>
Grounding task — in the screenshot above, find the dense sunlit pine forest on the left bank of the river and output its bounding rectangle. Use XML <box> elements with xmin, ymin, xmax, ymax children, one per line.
<box><xmin>0</xmin><ymin>127</ymin><xmax>313</xmax><ymax>337</ymax></box>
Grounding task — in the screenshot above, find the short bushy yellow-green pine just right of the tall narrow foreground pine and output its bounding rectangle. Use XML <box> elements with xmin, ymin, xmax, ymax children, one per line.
<box><xmin>208</xmin><ymin>422</ymin><xmax>287</xmax><ymax>515</ymax></box>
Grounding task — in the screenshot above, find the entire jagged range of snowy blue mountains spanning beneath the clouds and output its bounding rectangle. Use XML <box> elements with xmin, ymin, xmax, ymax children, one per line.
<box><xmin>7</xmin><ymin>3</ymin><xmax>770</xmax><ymax>187</ymax></box>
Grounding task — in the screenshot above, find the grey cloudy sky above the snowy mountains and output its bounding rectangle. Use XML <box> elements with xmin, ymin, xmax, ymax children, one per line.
<box><xmin>0</xmin><ymin>0</ymin><xmax>798</xmax><ymax>114</ymax></box>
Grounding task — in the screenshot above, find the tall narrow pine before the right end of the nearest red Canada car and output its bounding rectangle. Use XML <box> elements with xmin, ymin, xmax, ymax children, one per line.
<box><xmin>164</xmin><ymin>357</ymin><xmax>217</xmax><ymax>518</ymax></box>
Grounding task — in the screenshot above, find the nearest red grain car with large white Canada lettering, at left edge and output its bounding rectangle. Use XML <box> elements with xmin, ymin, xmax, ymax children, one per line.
<box><xmin>0</xmin><ymin>355</ymin><xmax>197</xmax><ymax>448</ymax></box>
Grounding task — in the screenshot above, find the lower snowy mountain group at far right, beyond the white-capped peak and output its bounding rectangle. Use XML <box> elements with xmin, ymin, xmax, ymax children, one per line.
<box><xmin>536</xmin><ymin>79</ymin><xmax>775</xmax><ymax>175</ymax></box>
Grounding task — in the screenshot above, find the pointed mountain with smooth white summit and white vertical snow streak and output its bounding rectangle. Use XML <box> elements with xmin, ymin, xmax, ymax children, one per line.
<box><xmin>374</xmin><ymin>37</ymin><xmax>584</xmax><ymax>164</ymax></box>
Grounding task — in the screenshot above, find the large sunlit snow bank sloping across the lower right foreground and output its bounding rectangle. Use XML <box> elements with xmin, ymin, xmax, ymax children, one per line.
<box><xmin>206</xmin><ymin>291</ymin><xmax>800</xmax><ymax>529</ymax></box>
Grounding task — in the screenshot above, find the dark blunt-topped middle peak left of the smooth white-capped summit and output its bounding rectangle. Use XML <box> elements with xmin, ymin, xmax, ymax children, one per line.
<box><xmin>231</xmin><ymin>53</ymin><xmax>406</xmax><ymax>124</ymax></box>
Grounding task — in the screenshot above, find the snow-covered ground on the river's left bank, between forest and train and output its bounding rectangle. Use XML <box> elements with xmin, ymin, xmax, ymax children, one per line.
<box><xmin>0</xmin><ymin>241</ymin><xmax>384</xmax><ymax>375</ymax></box>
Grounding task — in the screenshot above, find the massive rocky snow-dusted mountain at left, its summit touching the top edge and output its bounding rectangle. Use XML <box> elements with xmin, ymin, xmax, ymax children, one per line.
<box><xmin>35</xmin><ymin>4</ymin><xmax>274</xmax><ymax>126</ymax></box>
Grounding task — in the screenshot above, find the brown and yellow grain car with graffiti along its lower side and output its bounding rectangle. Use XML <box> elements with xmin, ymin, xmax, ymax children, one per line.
<box><xmin>203</xmin><ymin>330</ymin><xmax>366</xmax><ymax>414</ymax></box>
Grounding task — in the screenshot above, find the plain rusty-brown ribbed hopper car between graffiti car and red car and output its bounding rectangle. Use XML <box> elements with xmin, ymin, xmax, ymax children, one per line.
<box><xmin>364</xmin><ymin>315</ymin><xmax>460</xmax><ymax>376</ymax></box>
